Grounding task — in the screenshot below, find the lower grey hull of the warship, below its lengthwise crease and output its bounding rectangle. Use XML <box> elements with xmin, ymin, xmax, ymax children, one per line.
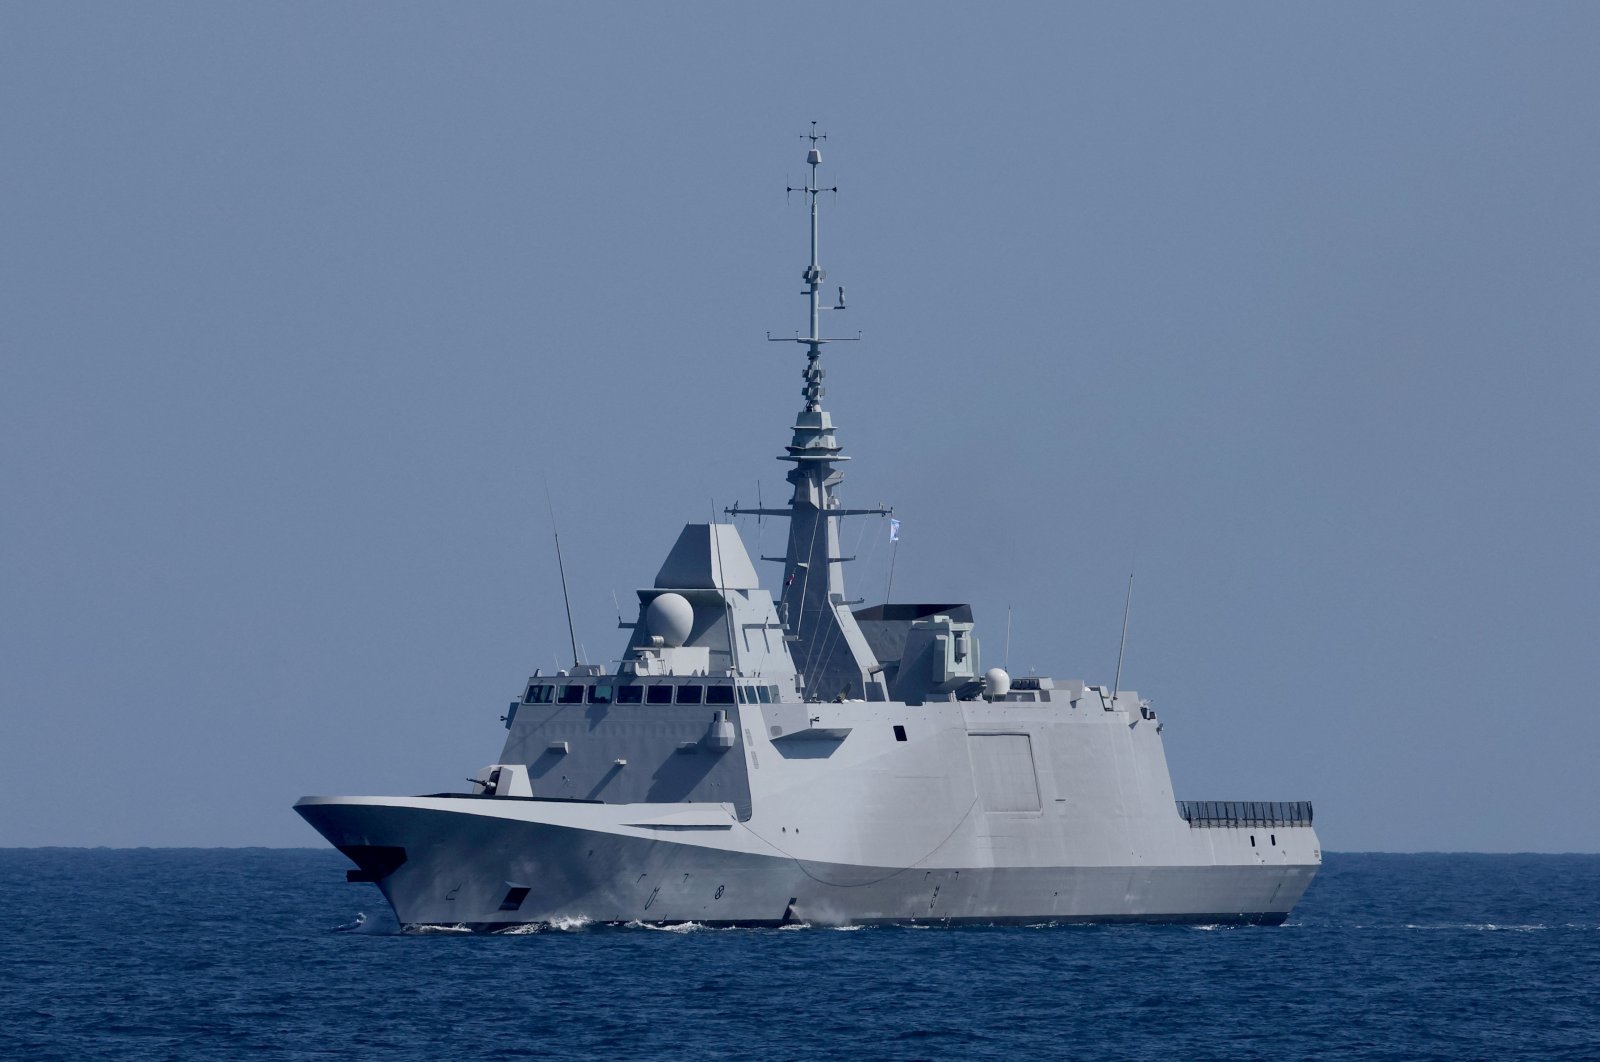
<box><xmin>296</xmin><ymin>797</ymin><xmax>1317</xmax><ymax>931</ymax></box>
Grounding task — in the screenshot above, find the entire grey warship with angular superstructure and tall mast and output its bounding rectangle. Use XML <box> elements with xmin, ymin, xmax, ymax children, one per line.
<box><xmin>294</xmin><ymin>126</ymin><xmax>1322</xmax><ymax>931</ymax></box>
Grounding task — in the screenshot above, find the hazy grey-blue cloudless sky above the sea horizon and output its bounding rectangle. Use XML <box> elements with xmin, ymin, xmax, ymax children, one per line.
<box><xmin>0</xmin><ymin>2</ymin><xmax>1600</xmax><ymax>851</ymax></box>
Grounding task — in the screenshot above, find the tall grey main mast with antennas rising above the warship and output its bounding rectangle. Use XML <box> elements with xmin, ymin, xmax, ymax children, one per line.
<box><xmin>728</xmin><ymin>122</ymin><xmax>888</xmax><ymax>701</ymax></box>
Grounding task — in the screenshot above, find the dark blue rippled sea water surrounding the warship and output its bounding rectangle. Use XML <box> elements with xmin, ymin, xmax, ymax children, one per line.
<box><xmin>0</xmin><ymin>849</ymin><xmax>1600</xmax><ymax>1060</ymax></box>
